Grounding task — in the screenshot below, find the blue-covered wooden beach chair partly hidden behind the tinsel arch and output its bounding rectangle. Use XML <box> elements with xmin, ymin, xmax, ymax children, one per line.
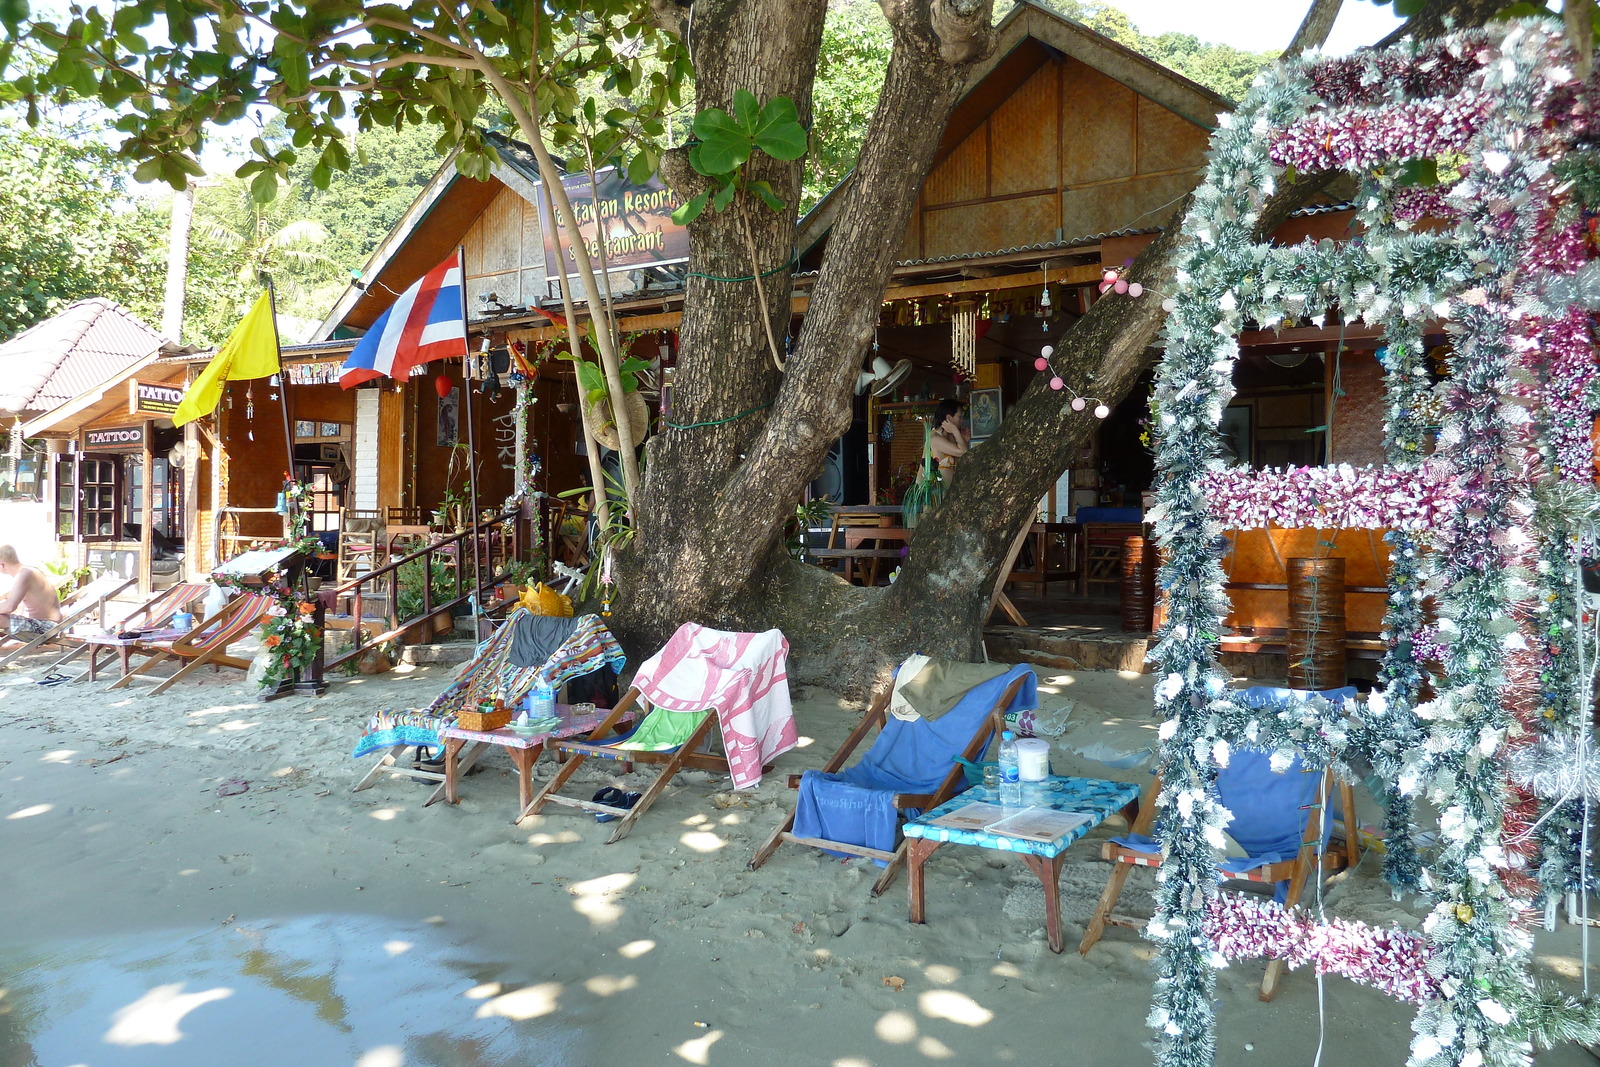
<box><xmin>1078</xmin><ymin>686</ymin><xmax>1362</xmax><ymax>1000</ymax></box>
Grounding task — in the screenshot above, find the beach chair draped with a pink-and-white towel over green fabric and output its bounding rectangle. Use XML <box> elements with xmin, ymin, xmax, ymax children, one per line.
<box><xmin>517</xmin><ymin>622</ymin><xmax>798</xmax><ymax>845</ymax></box>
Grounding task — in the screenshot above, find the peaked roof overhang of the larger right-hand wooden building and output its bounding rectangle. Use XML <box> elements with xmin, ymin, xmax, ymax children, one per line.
<box><xmin>795</xmin><ymin>0</ymin><xmax>1234</xmax><ymax>256</ymax></box>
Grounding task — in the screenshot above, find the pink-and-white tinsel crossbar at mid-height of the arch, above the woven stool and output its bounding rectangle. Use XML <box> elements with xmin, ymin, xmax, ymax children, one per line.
<box><xmin>1202</xmin><ymin>464</ymin><xmax>1456</xmax><ymax>531</ymax></box>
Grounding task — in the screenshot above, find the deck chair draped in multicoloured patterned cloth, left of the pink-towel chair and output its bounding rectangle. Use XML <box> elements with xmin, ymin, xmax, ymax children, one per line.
<box><xmin>350</xmin><ymin>608</ymin><xmax>627</xmax><ymax>806</ymax></box>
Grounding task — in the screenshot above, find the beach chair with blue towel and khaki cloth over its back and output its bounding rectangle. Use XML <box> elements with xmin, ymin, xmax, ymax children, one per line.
<box><xmin>750</xmin><ymin>656</ymin><xmax>1038</xmax><ymax>896</ymax></box>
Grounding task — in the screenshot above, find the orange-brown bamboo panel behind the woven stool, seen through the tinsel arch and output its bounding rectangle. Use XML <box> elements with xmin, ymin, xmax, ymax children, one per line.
<box><xmin>1222</xmin><ymin>530</ymin><xmax>1389</xmax><ymax>633</ymax></box>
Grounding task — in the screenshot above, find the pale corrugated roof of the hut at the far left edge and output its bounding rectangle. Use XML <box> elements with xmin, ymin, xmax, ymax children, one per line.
<box><xmin>0</xmin><ymin>296</ymin><xmax>166</xmax><ymax>413</ymax></box>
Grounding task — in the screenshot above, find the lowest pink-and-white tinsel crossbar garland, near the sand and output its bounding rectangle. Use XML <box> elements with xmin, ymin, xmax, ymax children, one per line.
<box><xmin>1205</xmin><ymin>893</ymin><xmax>1438</xmax><ymax>1005</ymax></box>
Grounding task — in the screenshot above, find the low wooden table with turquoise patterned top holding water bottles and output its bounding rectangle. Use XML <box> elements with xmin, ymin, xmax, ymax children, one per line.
<box><xmin>906</xmin><ymin>776</ymin><xmax>1139</xmax><ymax>952</ymax></box>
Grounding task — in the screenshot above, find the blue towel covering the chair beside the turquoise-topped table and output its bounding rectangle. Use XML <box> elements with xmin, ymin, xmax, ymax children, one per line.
<box><xmin>794</xmin><ymin>664</ymin><xmax>1038</xmax><ymax>867</ymax></box>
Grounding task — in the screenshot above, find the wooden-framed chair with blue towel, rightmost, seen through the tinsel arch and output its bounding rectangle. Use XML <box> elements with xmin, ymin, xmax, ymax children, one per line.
<box><xmin>1078</xmin><ymin>689</ymin><xmax>1362</xmax><ymax>1000</ymax></box>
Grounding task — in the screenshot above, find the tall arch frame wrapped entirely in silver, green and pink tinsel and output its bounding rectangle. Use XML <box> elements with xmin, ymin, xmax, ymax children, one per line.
<box><xmin>1147</xmin><ymin>21</ymin><xmax>1600</xmax><ymax>1067</ymax></box>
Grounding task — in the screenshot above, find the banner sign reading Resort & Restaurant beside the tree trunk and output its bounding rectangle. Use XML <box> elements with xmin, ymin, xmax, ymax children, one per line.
<box><xmin>539</xmin><ymin>166</ymin><xmax>690</xmax><ymax>277</ymax></box>
